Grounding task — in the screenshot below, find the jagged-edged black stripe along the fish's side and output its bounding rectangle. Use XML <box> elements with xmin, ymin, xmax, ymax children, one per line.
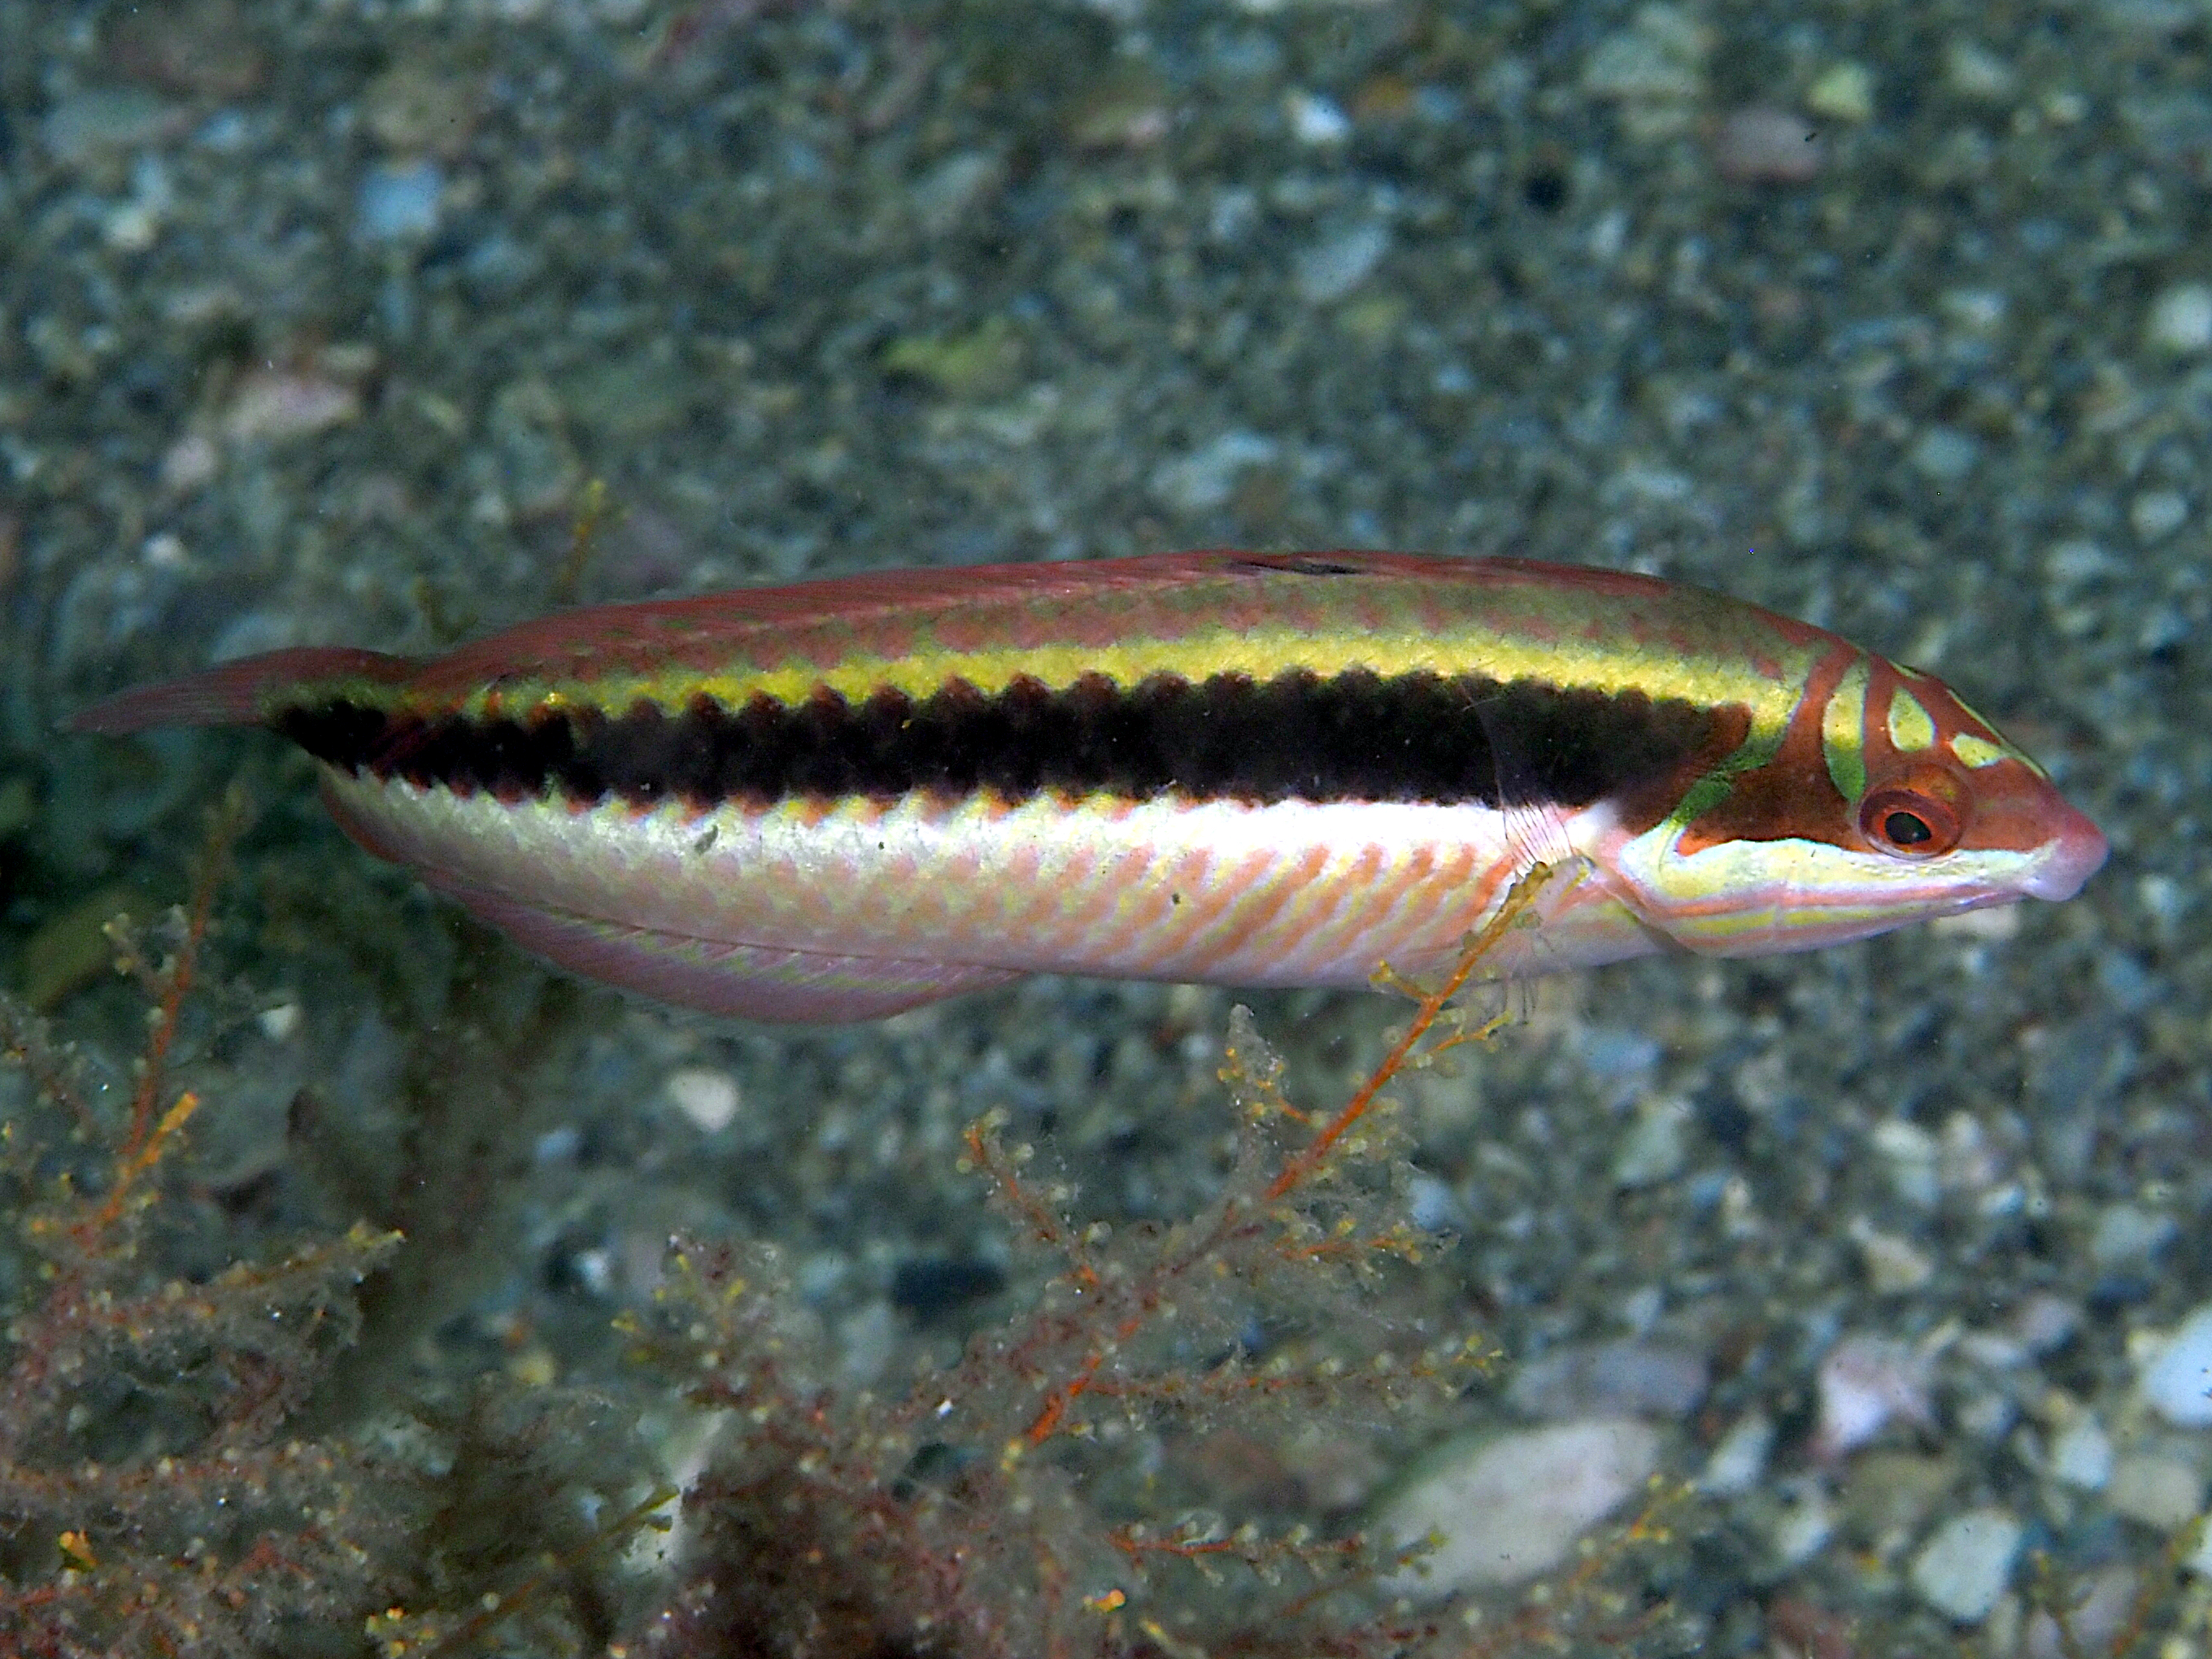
<box><xmin>276</xmin><ymin>670</ymin><xmax>1721</xmax><ymax>808</ymax></box>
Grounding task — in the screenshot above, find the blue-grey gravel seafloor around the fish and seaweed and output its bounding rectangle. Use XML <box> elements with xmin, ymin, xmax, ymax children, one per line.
<box><xmin>0</xmin><ymin>0</ymin><xmax>2212</xmax><ymax>1655</ymax></box>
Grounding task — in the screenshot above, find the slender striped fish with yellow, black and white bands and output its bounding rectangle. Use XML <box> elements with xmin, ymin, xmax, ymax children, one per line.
<box><xmin>68</xmin><ymin>551</ymin><xmax>2105</xmax><ymax>1022</ymax></box>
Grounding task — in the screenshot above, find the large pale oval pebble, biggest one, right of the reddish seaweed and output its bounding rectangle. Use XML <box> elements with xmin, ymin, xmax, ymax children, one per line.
<box><xmin>1378</xmin><ymin>1420</ymin><xmax>1659</xmax><ymax>1601</ymax></box>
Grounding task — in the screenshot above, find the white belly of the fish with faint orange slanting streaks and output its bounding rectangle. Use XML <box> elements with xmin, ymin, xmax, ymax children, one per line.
<box><xmin>325</xmin><ymin>772</ymin><xmax>1652</xmax><ymax>1020</ymax></box>
